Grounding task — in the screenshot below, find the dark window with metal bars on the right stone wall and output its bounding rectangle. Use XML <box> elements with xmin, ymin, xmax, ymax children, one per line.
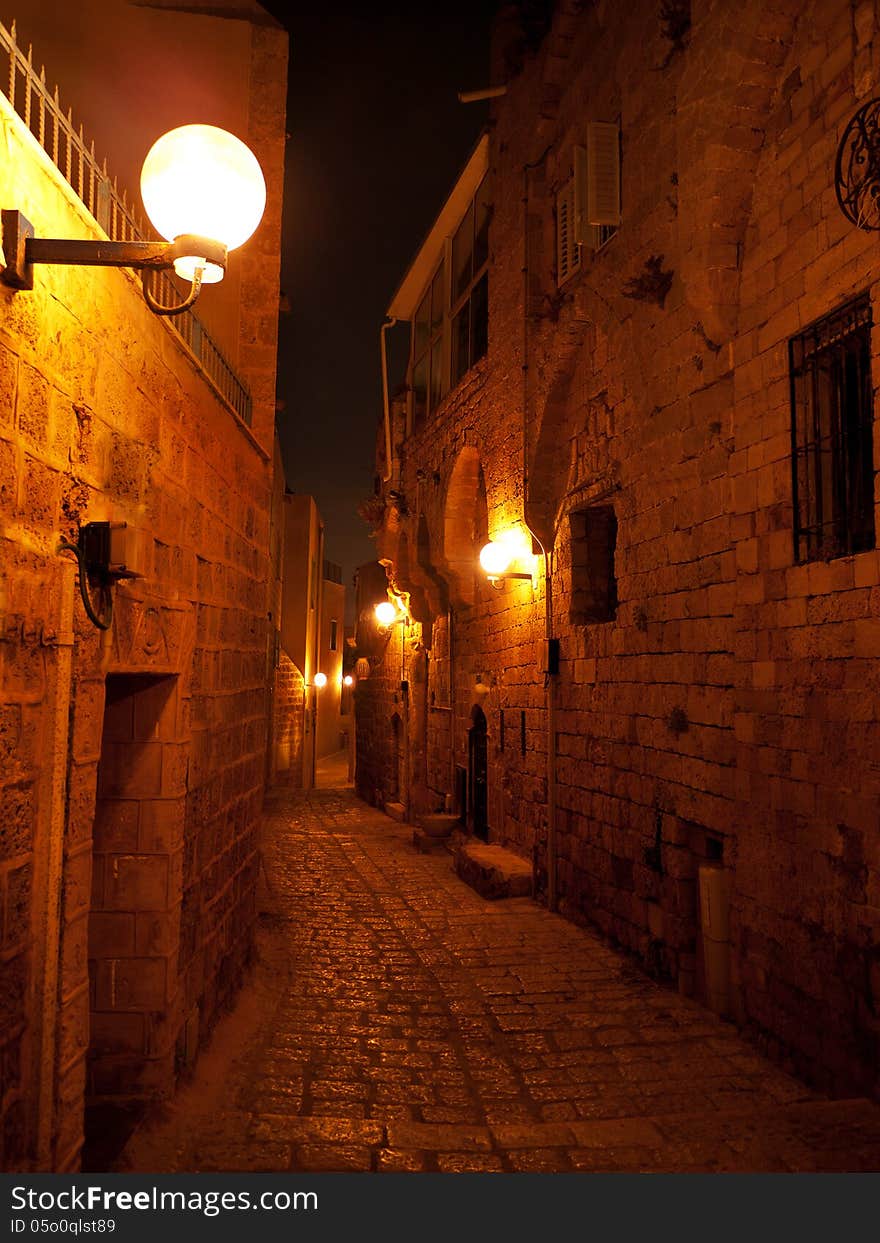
<box><xmin>789</xmin><ymin>297</ymin><xmax>875</xmax><ymax>561</ymax></box>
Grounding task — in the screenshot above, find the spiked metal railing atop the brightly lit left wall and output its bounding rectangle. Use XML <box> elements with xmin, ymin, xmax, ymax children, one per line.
<box><xmin>0</xmin><ymin>22</ymin><xmax>252</xmax><ymax>428</ymax></box>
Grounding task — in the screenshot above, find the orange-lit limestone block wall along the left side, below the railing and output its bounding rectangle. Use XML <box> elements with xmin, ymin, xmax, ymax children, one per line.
<box><xmin>0</xmin><ymin>70</ymin><xmax>281</xmax><ymax>1170</ymax></box>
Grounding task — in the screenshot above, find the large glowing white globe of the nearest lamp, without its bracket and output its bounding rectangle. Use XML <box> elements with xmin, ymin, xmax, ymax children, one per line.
<box><xmin>140</xmin><ymin>126</ymin><xmax>266</xmax><ymax>285</ymax></box>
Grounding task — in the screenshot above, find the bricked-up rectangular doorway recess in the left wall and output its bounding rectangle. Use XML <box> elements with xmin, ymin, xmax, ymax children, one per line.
<box><xmin>87</xmin><ymin>674</ymin><xmax>188</xmax><ymax>1163</ymax></box>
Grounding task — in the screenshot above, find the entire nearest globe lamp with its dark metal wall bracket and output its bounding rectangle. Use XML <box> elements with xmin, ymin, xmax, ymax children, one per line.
<box><xmin>0</xmin><ymin>126</ymin><xmax>266</xmax><ymax>314</ymax></box>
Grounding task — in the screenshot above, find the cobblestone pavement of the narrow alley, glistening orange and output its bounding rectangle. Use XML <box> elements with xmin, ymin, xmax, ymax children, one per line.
<box><xmin>117</xmin><ymin>789</ymin><xmax>880</xmax><ymax>1172</ymax></box>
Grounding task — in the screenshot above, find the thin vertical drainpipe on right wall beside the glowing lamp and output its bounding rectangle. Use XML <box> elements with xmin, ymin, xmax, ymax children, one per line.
<box><xmin>522</xmin><ymin>147</ymin><xmax>558</xmax><ymax>911</ymax></box>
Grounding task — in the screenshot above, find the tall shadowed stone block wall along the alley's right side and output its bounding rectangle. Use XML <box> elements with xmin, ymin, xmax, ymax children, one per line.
<box><xmin>358</xmin><ymin>0</ymin><xmax>880</xmax><ymax>1091</ymax></box>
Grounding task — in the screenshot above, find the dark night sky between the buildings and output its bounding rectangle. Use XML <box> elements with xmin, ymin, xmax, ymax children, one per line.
<box><xmin>264</xmin><ymin>0</ymin><xmax>495</xmax><ymax>596</ymax></box>
